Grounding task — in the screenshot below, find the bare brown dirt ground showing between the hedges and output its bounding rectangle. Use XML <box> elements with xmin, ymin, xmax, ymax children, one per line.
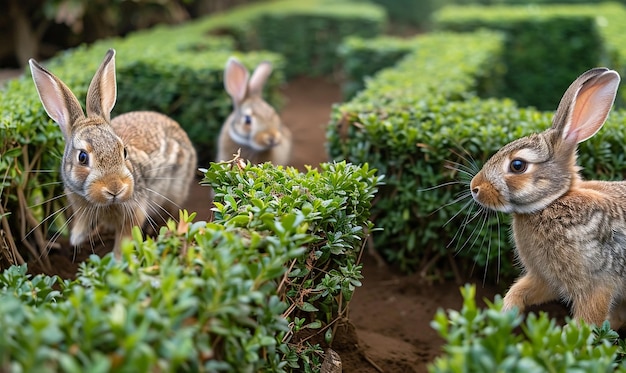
<box><xmin>12</xmin><ymin>72</ymin><xmax>564</xmax><ymax>373</ymax></box>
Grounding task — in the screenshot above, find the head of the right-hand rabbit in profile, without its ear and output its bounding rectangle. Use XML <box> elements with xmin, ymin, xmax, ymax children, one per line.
<box><xmin>470</xmin><ymin>131</ymin><xmax>575</xmax><ymax>214</ymax></box>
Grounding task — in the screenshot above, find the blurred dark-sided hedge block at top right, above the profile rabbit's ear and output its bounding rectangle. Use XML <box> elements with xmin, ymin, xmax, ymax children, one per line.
<box><xmin>434</xmin><ymin>5</ymin><xmax>612</xmax><ymax>110</ymax></box>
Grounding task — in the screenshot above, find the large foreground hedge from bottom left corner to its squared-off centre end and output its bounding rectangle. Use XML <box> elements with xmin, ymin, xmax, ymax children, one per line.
<box><xmin>0</xmin><ymin>163</ymin><xmax>380</xmax><ymax>372</ymax></box>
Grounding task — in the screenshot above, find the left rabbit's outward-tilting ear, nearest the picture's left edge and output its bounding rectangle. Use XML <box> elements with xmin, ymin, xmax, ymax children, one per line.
<box><xmin>28</xmin><ymin>58</ymin><xmax>85</xmax><ymax>139</ymax></box>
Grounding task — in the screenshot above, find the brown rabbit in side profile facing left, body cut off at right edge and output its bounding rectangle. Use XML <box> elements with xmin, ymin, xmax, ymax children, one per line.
<box><xmin>470</xmin><ymin>68</ymin><xmax>626</xmax><ymax>329</ymax></box>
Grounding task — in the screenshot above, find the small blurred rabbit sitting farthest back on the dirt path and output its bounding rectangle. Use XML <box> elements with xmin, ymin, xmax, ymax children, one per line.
<box><xmin>217</xmin><ymin>57</ymin><xmax>292</xmax><ymax>166</ymax></box>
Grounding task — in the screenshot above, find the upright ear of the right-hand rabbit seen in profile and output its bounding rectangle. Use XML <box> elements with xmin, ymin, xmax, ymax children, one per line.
<box><xmin>552</xmin><ymin>68</ymin><xmax>620</xmax><ymax>144</ymax></box>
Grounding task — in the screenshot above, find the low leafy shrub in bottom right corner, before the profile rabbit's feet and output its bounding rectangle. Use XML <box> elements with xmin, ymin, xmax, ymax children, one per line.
<box><xmin>429</xmin><ymin>285</ymin><xmax>626</xmax><ymax>373</ymax></box>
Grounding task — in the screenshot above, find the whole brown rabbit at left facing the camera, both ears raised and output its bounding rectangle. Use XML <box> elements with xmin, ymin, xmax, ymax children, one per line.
<box><xmin>29</xmin><ymin>49</ymin><xmax>197</xmax><ymax>258</ymax></box>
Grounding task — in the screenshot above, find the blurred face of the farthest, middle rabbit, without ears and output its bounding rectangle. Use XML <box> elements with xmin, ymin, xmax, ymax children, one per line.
<box><xmin>231</xmin><ymin>99</ymin><xmax>282</xmax><ymax>151</ymax></box>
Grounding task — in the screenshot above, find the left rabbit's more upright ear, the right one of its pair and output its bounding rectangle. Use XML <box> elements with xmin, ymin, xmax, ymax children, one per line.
<box><xmin>87</xmin><ymin>49</ymin><xmax>117</xmax><ymax>122</ymax></box>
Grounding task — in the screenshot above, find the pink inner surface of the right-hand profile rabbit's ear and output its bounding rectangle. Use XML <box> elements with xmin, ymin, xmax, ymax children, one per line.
<box><xmin>564</xmin><ymin>70</ymin><xmax>620</xmax><ymax>143</ymax></box>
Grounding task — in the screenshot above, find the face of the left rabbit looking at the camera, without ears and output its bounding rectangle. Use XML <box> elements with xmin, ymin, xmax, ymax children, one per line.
<box><xmin>63</xmin><ymin>122</ymin><xmax>134</xmax><ymax>206</ymax></box>
